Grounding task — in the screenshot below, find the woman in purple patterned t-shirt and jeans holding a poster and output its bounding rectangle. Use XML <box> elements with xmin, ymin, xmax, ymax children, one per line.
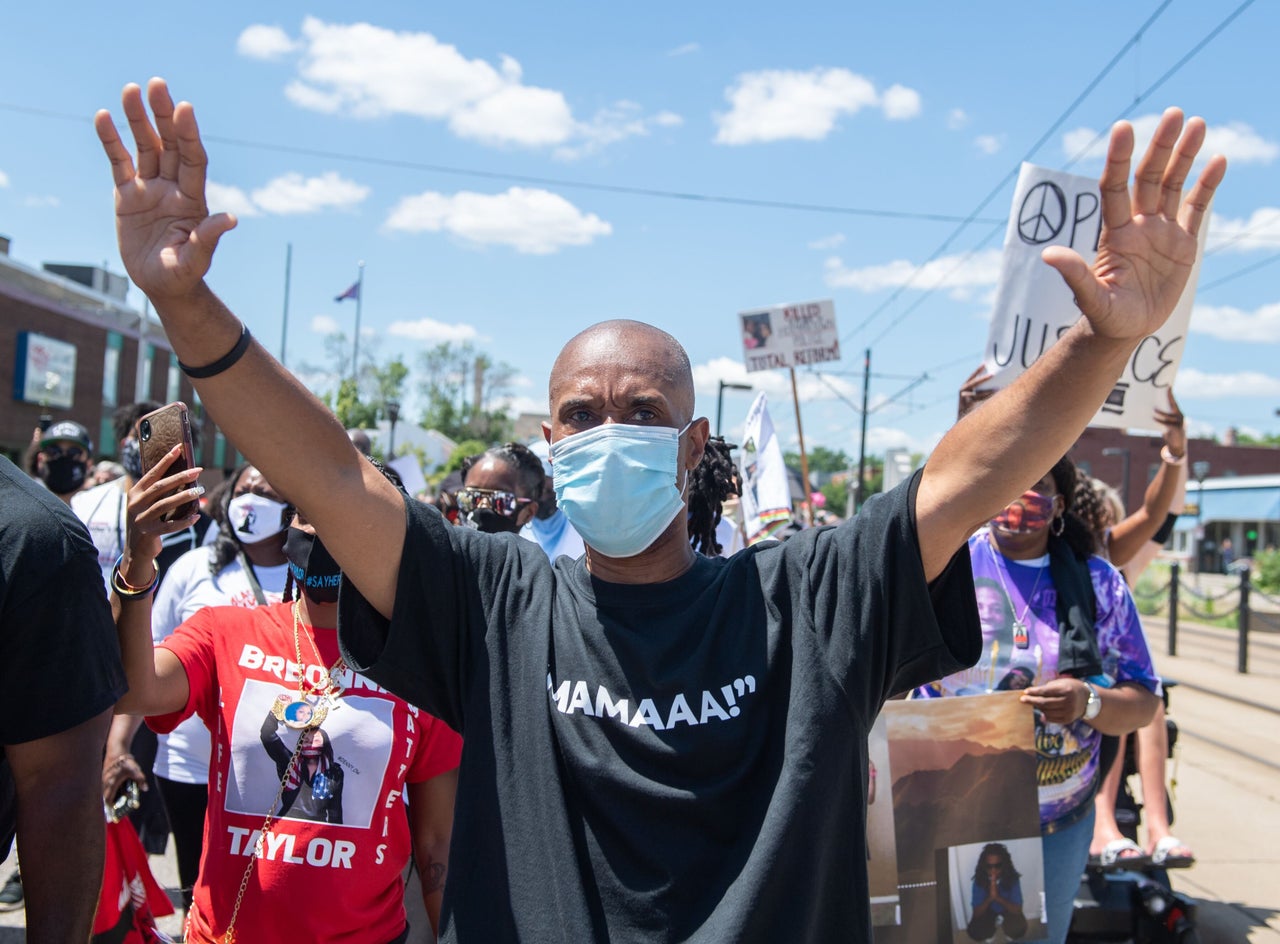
<box><xmin>915</xmin><ymin>457</ymin><xmax>1160</xmax><ymax>944</ymax></box>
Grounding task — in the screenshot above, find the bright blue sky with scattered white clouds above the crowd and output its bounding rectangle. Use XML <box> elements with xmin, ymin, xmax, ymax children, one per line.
<box><xmin>0</xmin><ymin>0</ymin><xmax>1280</xmax><ymax>455</ymax></box>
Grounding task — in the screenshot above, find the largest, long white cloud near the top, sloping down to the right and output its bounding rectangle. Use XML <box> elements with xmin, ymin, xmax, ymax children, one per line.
<box><xmin>256</xmin><ymin>17</ymin><xmax>680</xmax><ymax>157</ymax></box>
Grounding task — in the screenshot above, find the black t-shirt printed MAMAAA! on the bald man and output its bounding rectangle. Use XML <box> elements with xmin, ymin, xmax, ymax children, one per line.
<box><xmin>339</xmin><ymin>470</ymin><xmax>982</xmax><ymax>944</ymax></box>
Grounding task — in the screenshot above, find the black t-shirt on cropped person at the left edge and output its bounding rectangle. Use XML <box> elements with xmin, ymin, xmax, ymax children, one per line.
<box><xmin>0</xmin><ymin>457</ymin><xmax>127</xmax><ymax>859</ymax></box>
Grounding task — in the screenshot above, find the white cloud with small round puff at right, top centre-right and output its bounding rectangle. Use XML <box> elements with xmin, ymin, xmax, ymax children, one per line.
<box><xmin>716</xmin><ymin>69</ymin><xmax>920</xmax><ymax>145</ymax></box>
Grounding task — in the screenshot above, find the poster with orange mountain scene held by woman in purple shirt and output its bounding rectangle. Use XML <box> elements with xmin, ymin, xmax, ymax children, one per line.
<box><xmin>873</xmin><ymin>692</ymin><xmax>1044</xmax><ymax>944</ymax></box>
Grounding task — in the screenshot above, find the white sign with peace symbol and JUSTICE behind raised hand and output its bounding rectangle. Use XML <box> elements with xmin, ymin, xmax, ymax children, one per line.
<box><xmin>983</xmin><ymin>164</ymin><xmax>1208</xmax><ymax>429</ymax></box>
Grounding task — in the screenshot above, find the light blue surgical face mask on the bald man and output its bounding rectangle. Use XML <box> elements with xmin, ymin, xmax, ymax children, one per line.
<box><xmin>550</xmin><ymin>423</ymin><xmax>689</xmax><ymax>558</ymax></box>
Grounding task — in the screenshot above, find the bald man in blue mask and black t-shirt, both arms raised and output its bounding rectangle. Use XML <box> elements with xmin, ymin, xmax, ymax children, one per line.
<box><xmin>96</xmin><ymin>79</ymin><xmax>1225</xmax><ymax>943</ymax></box>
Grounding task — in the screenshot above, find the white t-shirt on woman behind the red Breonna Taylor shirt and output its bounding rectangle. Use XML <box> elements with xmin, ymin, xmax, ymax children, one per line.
<box><xmin>149</xmin><ymin>539</ymin><xmax>289</xmax><ymax>784</ymax></box>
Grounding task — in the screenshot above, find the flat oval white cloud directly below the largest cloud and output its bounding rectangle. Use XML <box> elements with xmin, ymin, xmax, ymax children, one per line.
<box><xmin>384</xmin><ymin>187</ymin><xmax>613</xmax><ymax>256</ymax></box>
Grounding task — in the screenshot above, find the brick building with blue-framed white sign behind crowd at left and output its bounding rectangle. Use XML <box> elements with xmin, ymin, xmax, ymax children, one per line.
<box><xmin>0</xmin><ymin>237</ymin><xmax>238</xmax><ymax>469</ymax></box>
